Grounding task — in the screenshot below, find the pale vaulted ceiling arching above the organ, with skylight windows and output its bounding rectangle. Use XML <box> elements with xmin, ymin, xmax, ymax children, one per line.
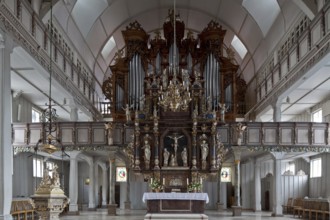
<box><xmin>44</xmin><ymin>0</ymin><xmax>312</xmax><ymax>85</ymax></box>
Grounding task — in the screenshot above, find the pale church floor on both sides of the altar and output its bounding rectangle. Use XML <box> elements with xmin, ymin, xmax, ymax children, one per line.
<box><xmin>60</xmin><ymin>210</ymin><xmax>297</xmax><ymax>220</ymax></box>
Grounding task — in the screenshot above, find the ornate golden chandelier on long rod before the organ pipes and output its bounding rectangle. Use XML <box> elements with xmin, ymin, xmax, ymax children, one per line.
<box><xmin>158</xmin><ymin>0</ymin><xmax>191</xmax><ymax>112</ymax></box>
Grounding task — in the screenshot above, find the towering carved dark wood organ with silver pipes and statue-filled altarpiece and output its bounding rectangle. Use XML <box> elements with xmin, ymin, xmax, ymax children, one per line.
<box><xmin>103</xmin><ymin>11</ymin><xmax>246</xmax><ymax>191</ymax></box>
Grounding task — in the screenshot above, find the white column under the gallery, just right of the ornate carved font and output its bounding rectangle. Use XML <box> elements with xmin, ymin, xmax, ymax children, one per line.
<box><xmin>69</xmin><ymin>152</ymin><xmax>80</xmax><ymax>214</ymax></box>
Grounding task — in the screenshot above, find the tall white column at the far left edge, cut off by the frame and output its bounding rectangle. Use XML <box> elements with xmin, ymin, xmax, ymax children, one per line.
<box><xmin>0</xmin><ymin>32</ymin><xmax>13</xmax><ymax>219</ymax></box>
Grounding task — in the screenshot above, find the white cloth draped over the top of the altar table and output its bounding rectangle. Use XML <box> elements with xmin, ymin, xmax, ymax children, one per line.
<box><xmin>142</xmin><ymin>192</ymin><xmax>209</xmax><ymax>203</ymax></box>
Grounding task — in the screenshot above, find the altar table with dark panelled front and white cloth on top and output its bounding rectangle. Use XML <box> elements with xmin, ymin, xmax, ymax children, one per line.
<box><xmin>142</xmin><ymin>192</ymin><xmax>209</xmax><ymax>213</ymax></box>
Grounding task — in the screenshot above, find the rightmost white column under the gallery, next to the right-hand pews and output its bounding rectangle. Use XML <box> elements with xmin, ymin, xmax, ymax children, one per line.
<box><xmin>272</xmin><ymin>152</ymin><xmax>284</xmax><ymax>216</ymax></box>
